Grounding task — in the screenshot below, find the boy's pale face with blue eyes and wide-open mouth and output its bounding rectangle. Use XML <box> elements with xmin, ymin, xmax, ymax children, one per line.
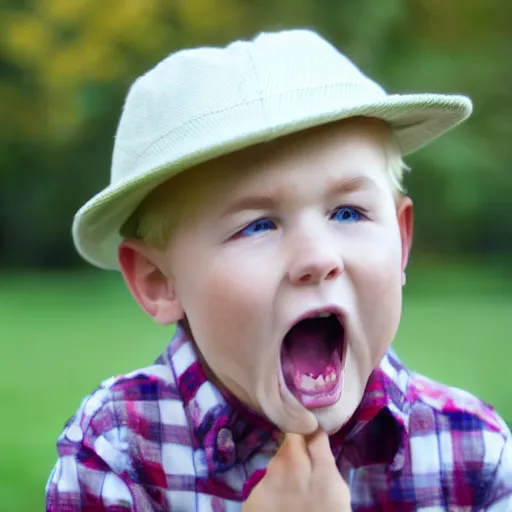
<box><xmin>123</xmin><ymin>119</ymin><xmax>412</xmax><ymax>434</ymax></box>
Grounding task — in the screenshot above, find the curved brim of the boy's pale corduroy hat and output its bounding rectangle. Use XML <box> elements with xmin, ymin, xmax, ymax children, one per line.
<box><xmin>72</xmin><ymin>94</ymin><xmax>472</xmax><ymax>270</ymax></box>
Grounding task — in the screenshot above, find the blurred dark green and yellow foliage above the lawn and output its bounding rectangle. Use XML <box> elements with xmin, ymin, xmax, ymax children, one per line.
<box><xmin>0</xmin><ymin>0</ymin><xmax>512</xmax><ymax>266</ymax></box>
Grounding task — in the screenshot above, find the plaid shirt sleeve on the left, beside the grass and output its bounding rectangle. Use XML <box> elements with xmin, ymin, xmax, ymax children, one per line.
<box><xmin>46</xmin><ymin>388</ymin><xmax>158</xmax><ymax>512</ymax></box>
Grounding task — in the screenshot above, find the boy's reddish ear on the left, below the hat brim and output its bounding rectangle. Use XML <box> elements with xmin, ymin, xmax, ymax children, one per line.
<box><xmin>118</xmin><ymin>239</ymin><xmax>184</xmax><ymax>325</ymax></box>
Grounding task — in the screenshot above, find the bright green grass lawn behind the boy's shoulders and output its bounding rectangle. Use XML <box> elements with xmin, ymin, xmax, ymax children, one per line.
<box><xmin>0</xmin><ymin>266</ymin><xmax>512</xmax><ymax>512</ymax></box>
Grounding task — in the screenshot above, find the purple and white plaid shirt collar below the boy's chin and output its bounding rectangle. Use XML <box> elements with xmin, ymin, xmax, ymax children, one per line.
<box><xmin>157</xmin><ymin>326</ymin><xmax>409</xmax><ymax>473</ymax></box>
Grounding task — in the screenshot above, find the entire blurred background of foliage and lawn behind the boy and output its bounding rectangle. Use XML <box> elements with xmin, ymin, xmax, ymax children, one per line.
<box><xmin>0</xmin><ymin>0</ymin><xmax>512</xmax><ymax>512</ymax></box>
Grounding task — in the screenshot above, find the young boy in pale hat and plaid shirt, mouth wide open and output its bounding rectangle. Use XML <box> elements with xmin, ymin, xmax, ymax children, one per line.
<box><xmin>46</xmin><ymin>30</ymin><xmax>512</xmax><ymax>512</ymax></box>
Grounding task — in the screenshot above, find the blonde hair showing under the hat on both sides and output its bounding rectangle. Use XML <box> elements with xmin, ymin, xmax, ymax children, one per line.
<box><xmin>120</xmin><ymin>132</ymin><xmax>410</xmax><ymax>249</ymax></box>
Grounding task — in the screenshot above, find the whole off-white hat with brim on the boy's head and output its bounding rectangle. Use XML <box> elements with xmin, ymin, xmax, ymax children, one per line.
<box><xmin>73</xmin><ymin>30</ymin><xmax>472</xmax><ymax>269</ymax></box>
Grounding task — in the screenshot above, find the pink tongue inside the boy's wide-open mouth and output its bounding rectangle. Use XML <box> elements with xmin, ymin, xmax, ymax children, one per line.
<box><xmin>286</xmin><ymin>321</ymin><xmax>332</xmax><ymax>377</ymax></box>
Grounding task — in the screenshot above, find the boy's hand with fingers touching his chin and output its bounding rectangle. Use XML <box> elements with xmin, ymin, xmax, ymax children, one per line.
<box><xmin>242</xmin><ymin>431</ymin><xmax>351</xmax><ymax>512</ymax></box>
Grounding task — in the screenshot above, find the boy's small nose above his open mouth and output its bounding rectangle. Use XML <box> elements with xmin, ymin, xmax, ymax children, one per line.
<box><xmin>288</xmin><ymin>230</ymin><xmax>343</xmax><ymax>285</ymax></box>
